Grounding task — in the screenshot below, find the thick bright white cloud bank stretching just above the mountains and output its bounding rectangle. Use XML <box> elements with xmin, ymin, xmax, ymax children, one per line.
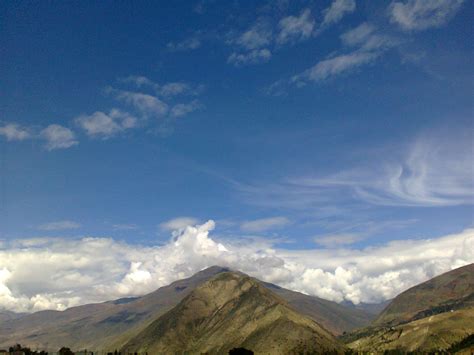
<box><xmin>0</xmin><ymin>221</ymin><xmax>474</xmax><ymax>311</ymax></box>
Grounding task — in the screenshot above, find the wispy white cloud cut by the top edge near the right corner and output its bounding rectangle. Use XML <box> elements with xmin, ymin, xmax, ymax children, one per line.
<box><xmin>389</xmin><ymin>0</ymin><xmax>464</xmax><ymax>30</ymax></box>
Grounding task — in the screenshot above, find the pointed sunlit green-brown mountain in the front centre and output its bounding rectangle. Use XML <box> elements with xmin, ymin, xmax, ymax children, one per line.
<box><xmin>122</xmin><ymin>272</ymin><xmax>344</xmax><ymax>354</ymax></box>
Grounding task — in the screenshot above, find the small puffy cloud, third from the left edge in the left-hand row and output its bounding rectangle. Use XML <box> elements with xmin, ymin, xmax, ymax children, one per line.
<box><xmin>75</xmin><ymin>109</ymin><xmax>138</xmax><ymax>138</ymax></box>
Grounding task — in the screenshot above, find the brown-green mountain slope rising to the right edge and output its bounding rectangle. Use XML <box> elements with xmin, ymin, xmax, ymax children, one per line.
<box><xmin>342</xmin><ymin>264</ymin><xmax>474</xmax><ymax>352</ymax></box>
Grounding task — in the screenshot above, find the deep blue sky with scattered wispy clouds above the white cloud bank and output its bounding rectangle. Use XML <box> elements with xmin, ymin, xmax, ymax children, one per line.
<box><xmin>0</xmin><ymin>0</ymin><xmax>474</xmax><ymax>248</ymax></box>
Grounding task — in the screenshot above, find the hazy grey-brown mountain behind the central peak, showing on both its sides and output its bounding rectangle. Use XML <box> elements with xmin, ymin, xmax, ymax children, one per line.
<box><xmin>0</xmin><ymin>266</ymin><xmax>373</xmax><ymax>350</ymax></box>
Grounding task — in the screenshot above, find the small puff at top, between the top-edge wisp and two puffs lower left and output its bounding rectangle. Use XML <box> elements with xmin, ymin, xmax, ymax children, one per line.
<box><xmin>277</xmin><ymin>9</ymin><xmax>315</xmax><ymax>44</ymax></box>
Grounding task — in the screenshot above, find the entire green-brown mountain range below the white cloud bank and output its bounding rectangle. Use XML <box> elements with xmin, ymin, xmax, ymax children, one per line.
<box><xmin>0</xmin><ymin>264</ymin><xmax>474</xmax><ymax>355</ymax></box>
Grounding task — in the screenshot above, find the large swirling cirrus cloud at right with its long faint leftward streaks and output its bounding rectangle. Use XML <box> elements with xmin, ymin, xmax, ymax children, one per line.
<box><xmin>235</xmin><ymin>129</ymin><xmax>474</xmax><ymax>211</ymax></box>
